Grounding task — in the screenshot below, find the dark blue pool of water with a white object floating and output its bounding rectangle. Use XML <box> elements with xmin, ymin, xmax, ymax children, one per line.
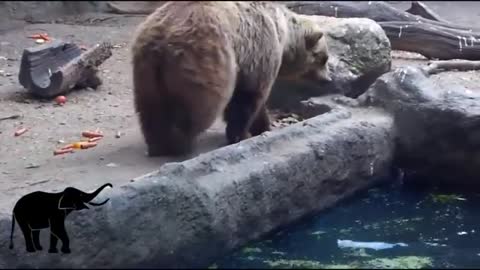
<box><xmin>210</xmin><ymin>182</ymin><xmax>480</xmax><ymax>269</ymax></box>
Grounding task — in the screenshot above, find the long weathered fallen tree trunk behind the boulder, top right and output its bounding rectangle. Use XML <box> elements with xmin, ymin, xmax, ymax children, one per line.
<box><xmin>286</xmin><ymin>1</ymin><xmax>480</xmax><ymax>60</ymax></box>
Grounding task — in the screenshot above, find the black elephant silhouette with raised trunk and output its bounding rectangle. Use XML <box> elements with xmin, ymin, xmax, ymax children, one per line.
<box><xmin>10</xmin><ymin>183</ymin><xmax>113</xmax><ymax>253</ymax></box>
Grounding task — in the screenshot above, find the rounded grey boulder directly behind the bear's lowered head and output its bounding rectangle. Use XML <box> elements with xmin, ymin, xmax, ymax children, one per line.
<box><xmin>269</xmin><ymin>16</ymin><xmax>392</xmax><ymax>108</ymax></box>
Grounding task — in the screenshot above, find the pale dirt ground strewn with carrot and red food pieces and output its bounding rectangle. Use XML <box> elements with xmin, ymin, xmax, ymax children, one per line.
<box><xmin>0</xmin><ymin>2</ymin><xmax>480</xmax><ymax>212</ymax></box>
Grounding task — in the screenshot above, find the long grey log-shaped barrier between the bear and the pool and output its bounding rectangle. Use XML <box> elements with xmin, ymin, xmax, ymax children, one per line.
<box><xmin>0</xmin><ymin>107</ymin><xmax>395</xmax><ymax>268</ymax></box>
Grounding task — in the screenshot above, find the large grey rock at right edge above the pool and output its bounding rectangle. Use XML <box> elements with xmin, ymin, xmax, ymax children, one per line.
<box><xmin>358</xmin><ymin>67</ymin><xmax>480</xmax><ymax>188</ymax></box>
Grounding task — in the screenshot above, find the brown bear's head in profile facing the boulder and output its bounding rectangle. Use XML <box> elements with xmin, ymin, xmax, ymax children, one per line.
<box><xmin>279</xmin><ymin>16</ymin><xmax>332</xmax><ymax>84</ymax></box>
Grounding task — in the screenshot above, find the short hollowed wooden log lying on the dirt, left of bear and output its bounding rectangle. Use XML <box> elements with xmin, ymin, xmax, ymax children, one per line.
<box><xmin>19</xmin><ymin>40</ymin><xmax>112</xmax><ymax>98</ymax></box>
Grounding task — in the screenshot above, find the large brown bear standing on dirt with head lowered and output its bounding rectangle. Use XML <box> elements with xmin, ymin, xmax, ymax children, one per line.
<box><xmin>131</xmin><ymin>1</ymin><xmax>330</xmax><ymax>156</ymax></box>
